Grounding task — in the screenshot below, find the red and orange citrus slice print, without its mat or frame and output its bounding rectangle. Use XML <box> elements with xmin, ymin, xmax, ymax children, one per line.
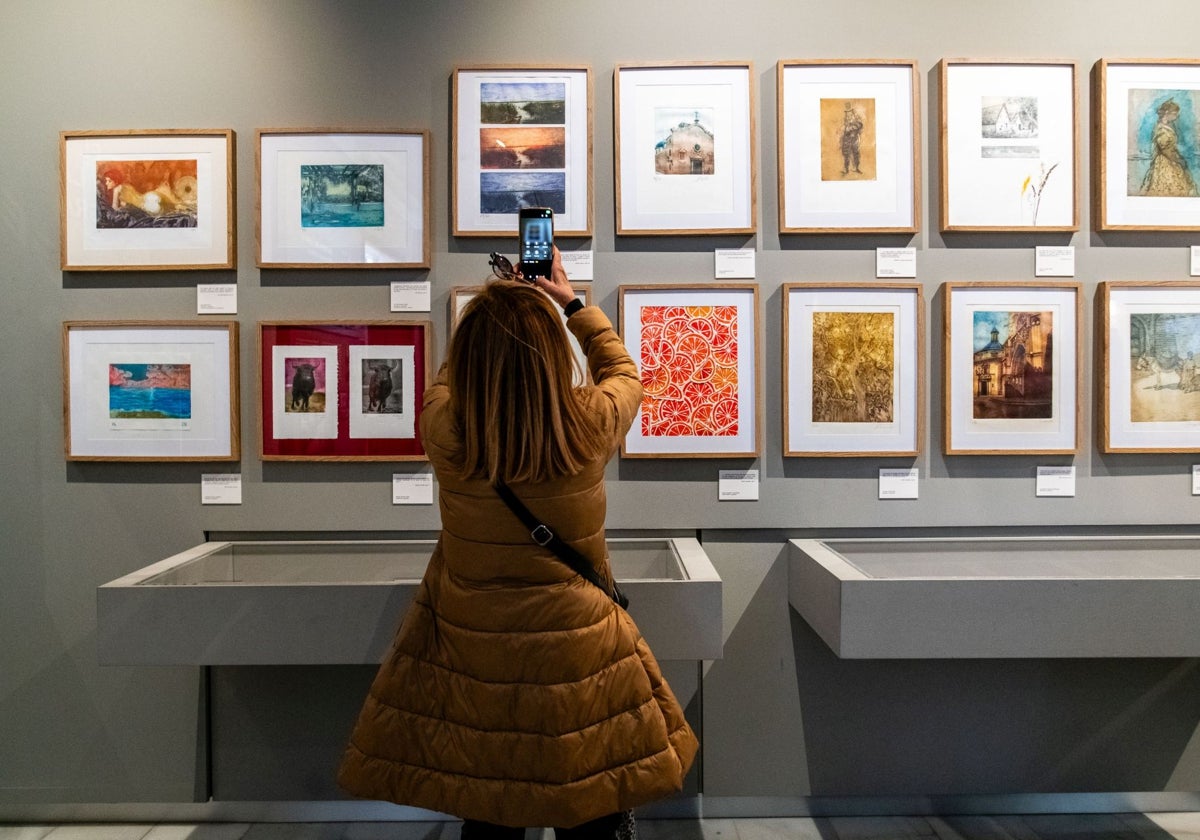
<box><xmin>638</xmin><ymin>306</ymin><xmax>739</xmax><ymax>438</ymax></box>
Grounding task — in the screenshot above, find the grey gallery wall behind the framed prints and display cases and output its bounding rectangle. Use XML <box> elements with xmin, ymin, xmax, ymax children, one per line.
<box><xmin>0</xmin><ymin>0</ymin><xmax>1200</xmax><ymax>817</ymax></box>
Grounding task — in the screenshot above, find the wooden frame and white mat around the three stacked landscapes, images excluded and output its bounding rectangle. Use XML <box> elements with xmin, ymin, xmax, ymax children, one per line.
<box><xmin>450</xmin><ymin>65</ymin><xmax>592</xmax><ymax>236</ymax></box>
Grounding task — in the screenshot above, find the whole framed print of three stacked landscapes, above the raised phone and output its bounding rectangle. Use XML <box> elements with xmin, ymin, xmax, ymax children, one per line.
<box><xmin>450</xmin><ymin>65</ymin><xmax>592</xmax><ymax>236</ymax></box>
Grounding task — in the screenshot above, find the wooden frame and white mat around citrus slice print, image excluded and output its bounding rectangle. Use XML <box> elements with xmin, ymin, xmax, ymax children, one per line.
<box><xmin>618</xmin><ymin>283</ymin><xmax>762</xmax><ymax>458</ymax></box>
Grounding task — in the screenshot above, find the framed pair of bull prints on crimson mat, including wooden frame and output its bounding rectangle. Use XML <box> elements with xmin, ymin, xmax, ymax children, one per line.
<box><xmin>258</xmin><ymin>320</ymin><xmax>432</xmax><ymax>461</ymax></box>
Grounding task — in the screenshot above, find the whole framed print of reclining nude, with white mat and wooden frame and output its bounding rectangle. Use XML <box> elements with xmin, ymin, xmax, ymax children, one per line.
<box><xmin>59</xmin><ymin>128</ymin><xmax>235</xmax><ymax>271</ymax></box>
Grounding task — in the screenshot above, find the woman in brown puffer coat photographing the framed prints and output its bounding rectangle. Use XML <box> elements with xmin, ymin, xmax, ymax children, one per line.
<box><xmin>338</xmin><ymin>250</ymin><xmax>697</xmax><ymax>840</ymax></box>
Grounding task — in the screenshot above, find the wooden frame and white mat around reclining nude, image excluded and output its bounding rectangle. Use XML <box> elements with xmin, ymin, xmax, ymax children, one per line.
<box><xmin>59</xmin><ymin>128</ymin><xmax>236</xmax><ymax>271</ymax></box>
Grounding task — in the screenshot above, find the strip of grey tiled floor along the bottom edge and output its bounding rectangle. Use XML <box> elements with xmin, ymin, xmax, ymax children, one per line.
<box><xmin>0</xmin><ymin>814</ymin><xmax>1200</xmax><ymax>840</ymax></box>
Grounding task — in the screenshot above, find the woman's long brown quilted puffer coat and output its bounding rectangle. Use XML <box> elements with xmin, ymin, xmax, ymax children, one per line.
<box><xmin>338</xmin><ymin>307</ymin><xmax>697</xmax><ymax>827</ymax></box>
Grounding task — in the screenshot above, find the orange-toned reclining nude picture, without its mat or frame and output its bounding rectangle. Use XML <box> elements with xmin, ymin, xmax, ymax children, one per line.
<box><xmin>96</xmin><ymin>158</ymin><xmax>199</xmax><ymax>229</ymax></box>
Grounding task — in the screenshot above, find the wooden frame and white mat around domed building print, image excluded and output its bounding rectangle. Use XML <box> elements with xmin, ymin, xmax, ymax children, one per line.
<box><xmin>943</xmin><ymin>281</ymin><xmax>1082</xmax><ymax>455</ymax></box>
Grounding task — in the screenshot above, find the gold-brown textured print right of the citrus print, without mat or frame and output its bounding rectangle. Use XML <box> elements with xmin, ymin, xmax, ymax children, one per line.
<box><xmin>812</xmin><ymin>312</ymin><xmax>896</xmax><ymax>422</ymax></box>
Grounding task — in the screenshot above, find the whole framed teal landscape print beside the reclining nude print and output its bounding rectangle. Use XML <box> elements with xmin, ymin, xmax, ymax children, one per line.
<box><xmin>254</xmin><ymin>128</ymin><xmax>430</xmax><ymax>269</ymax></box>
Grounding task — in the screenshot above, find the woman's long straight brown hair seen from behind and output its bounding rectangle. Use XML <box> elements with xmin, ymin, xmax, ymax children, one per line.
<box><xmin>446</xmin><ymin>281</ymin><xmax>604</xmax><ymax>484</ymax></box>
